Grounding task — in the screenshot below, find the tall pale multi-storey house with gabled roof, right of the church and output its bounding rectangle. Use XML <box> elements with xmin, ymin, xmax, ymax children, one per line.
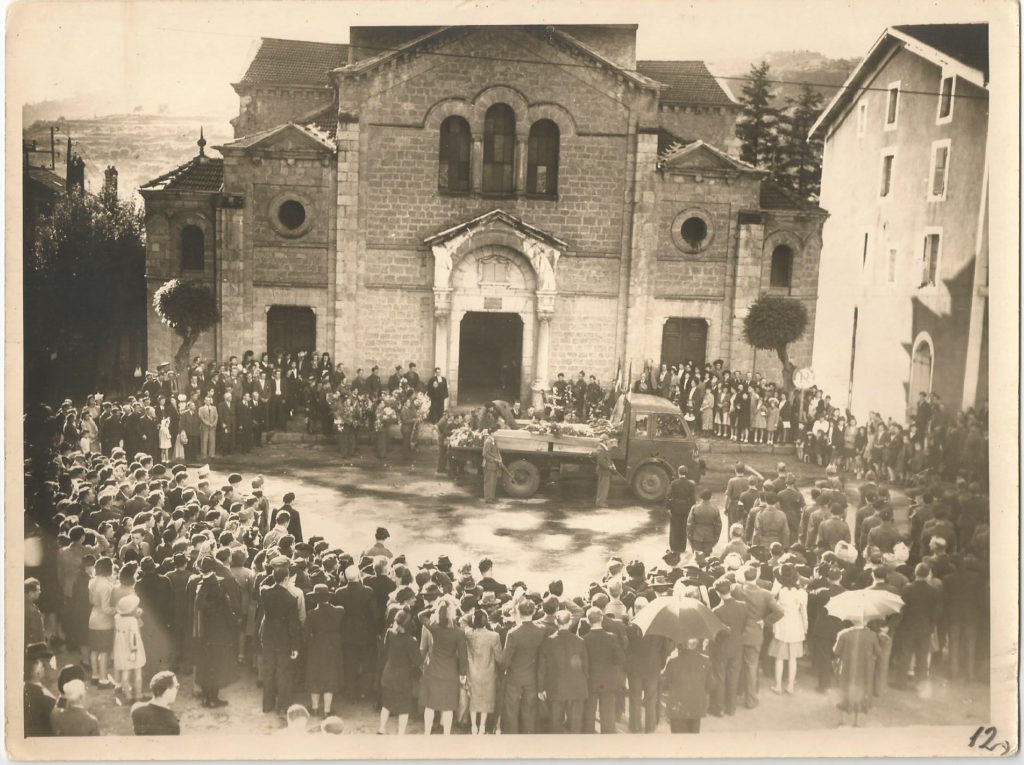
<box><xmin>812</xmin><ymin>24</ymin><xmax>989</xmax><ymax>420</ymax></box>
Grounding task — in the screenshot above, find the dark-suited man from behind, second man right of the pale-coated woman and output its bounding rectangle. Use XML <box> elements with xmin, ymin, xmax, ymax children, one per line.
<box><xmin>537</xmin><ymin>610</ymin><xmax>589</xmax><ymax>733</ymax></box>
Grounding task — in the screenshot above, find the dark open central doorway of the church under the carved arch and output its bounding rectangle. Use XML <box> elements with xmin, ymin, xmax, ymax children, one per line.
<box><xmin>459</xmin><ymin>311</ymin><xmax>522</xmax><ymax>405</ymax></box>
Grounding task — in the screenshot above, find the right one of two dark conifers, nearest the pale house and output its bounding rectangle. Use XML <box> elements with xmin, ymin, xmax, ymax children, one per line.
<box><xmin>777</xmin><ymin>85</ymin><xmax>823</xmax><ymax>202</ymax></box>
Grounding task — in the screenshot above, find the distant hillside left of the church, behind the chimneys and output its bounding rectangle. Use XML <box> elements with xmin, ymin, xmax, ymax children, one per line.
<box><xmin>23</xmin><ymin>114</ymin><xmax>234</xmax><ymax>202</ymax></box>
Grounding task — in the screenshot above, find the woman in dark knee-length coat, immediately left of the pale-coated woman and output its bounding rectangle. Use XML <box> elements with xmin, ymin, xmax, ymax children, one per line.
<box><xmin>420</xmin><ymin>596</ymin><xmax>468</xmax><ymax>735</ymax></box>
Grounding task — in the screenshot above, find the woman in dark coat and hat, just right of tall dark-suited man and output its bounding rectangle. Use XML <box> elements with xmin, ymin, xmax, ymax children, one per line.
<box><xmin>304</xmin><ymin>584</ymin><xmax>345</xmax><ymax>717</ymax></box>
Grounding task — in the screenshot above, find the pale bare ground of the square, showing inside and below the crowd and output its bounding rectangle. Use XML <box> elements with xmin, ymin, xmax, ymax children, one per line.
<box><xmin>61</xmin><ymin>443</ymin><xmax>988</xmax><ymax>734</ymax></box>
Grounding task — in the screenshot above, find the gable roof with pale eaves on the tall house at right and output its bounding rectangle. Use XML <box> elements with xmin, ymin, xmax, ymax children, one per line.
<box><xmin>810</xmin><ymin>24</ymin><xmax>988</xmax><ymax>135</ymax></box>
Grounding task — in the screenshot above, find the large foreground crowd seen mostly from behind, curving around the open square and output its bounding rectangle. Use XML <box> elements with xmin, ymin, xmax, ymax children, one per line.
<box><xmin>25</xmin><ymin>356</ymin><xmax>988</xmax><ymax>735</ymax></box>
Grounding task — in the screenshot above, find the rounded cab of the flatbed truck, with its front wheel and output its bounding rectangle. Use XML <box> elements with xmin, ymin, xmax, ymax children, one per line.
<box><xmin>610</xmin><ymin>393</ymin><xmax>703</xmax><ymax>502</ymax></box>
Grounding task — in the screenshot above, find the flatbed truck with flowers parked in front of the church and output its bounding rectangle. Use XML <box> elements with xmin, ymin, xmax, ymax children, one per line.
<box><xmin>449</xmin><ymin>392</ymin><xmax>705</xmax><ymax>504</ymax></box>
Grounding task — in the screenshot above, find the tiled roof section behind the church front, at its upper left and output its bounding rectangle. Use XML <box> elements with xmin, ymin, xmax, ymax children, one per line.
<box><xmin>242</xmin><ymin>37</ymin><xmax>348</xmax><ymax>87</ymax></box>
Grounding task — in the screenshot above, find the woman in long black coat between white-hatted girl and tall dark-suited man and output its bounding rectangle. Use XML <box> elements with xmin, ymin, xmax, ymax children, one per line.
<box><xmin>196</xmin><ymin>558</ymin><xmax>237</xmax><ymax>707</ymax></box>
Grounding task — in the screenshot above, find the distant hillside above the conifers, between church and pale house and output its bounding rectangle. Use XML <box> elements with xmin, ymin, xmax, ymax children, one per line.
<box><xmin>712</xmin><ymin>50</ymin><xmax>860</xmax><ymax>108</ymax></box>
